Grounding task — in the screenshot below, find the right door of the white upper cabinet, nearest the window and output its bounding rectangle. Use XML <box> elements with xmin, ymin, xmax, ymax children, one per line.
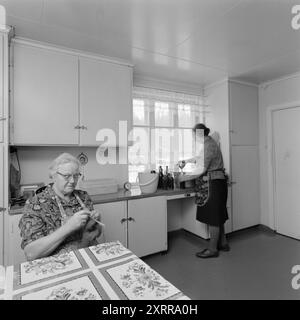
<box><xmin>79</xmin><ymin>58</ymin><xmax>132</xmax><ymax>145</ymax></box>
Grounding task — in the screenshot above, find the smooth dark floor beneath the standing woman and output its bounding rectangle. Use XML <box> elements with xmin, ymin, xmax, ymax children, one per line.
<box><xmin>143</xmin><ymin>227</ymin><xmax>300</xmax><ymax>299</ymax></box>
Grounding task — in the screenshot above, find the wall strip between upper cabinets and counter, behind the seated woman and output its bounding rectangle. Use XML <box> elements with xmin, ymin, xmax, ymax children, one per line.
<box><xmin>13</xmin><ymin>147</ymin><xmax>128</xmax><ymax>187</ymax></box>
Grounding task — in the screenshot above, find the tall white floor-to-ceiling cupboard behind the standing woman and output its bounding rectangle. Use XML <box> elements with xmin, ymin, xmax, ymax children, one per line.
<box><xmin>205</xmin><ymin>80</ymin><xmax>260</xmax><ymax>233</ymax></box>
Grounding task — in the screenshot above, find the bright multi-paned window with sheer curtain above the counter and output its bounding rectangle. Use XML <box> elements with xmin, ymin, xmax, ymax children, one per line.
<box><xmin>128</xmin><ymin>87</ymin><xmax>210</xmax><ymax>183</ymax></box>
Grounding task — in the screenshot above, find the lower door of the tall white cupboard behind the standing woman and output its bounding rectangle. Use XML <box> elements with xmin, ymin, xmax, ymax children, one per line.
<box><xmin>231</xmin><ymin>146</ymin><xmax>260</xmax><ymax>231</ymax></box>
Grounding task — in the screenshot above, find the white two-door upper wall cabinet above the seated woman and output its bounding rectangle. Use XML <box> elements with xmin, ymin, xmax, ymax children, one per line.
<box><xmin>11</xmin><ymin>40</ymin><xmax>132</xmax><ymax>146</ymax></box>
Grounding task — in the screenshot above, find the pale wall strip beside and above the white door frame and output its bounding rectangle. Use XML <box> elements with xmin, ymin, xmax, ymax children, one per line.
<box><xmin>259</xmin><ymin>74</ymin><xmax>300</xmax><ymax>229</ymax></box>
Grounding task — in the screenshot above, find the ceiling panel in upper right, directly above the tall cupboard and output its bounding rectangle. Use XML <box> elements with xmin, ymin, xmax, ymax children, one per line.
<box><xmin>175</xmin><ymin>0</ymin><xmax>300</xmax><ymax>73</ymax></box>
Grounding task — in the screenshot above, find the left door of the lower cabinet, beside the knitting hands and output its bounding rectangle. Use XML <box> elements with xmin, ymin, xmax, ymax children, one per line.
<box><xmin>94</xmin><ymin>201</ymin><xmax>127</xmax><ymax>247</ymax></box>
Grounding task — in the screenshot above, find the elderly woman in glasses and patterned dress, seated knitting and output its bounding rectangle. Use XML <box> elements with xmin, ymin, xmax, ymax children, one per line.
<box><xmin>19</xmin><ymin>153</ymin><xmax>101</xmax><ymax>260</ymax></box>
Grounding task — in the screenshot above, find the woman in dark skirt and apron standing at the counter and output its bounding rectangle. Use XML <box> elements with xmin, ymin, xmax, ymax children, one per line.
<box><xmin>179</xmin><ymin>123</ymin><xmax>230</xmax><ymax>258</ymax></box>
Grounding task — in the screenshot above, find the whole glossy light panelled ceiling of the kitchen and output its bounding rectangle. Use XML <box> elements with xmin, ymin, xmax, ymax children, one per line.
<box><xmin>0</xmin><ymin>0</ymin><xmax>300</xmax><ymax>86</ymax></box>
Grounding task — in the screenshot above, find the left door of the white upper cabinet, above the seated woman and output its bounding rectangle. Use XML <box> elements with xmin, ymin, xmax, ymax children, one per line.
<box><xmin>12</xmin><ymin>43</ymin><xmax>79</xmax><ymax>145</ymax></box>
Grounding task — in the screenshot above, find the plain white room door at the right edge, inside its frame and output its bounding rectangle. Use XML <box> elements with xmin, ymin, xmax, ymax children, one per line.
<box><xmin>273</xmin><ymin>106</ymin><xmax>300</xmax><ymax>239</ymax></box>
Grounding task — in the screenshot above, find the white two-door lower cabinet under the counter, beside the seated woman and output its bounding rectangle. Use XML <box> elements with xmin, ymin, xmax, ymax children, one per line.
<box><xmin>94</xmin><ymin>197</ymin><xmax>168</xmax><ymax>257</ymax></box>
